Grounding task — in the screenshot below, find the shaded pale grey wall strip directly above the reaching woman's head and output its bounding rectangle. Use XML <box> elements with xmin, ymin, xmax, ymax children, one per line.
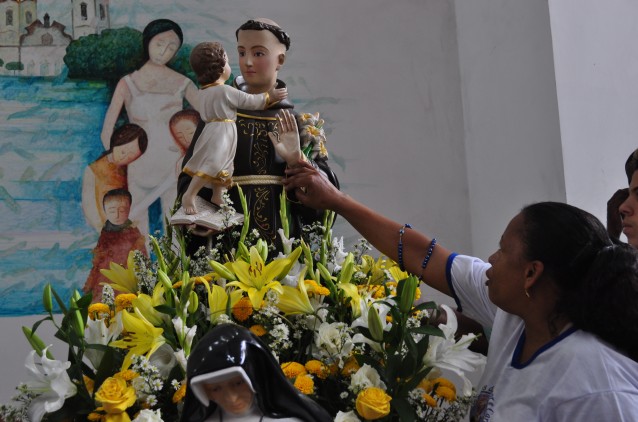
<box><xmin>455</xmin><ymin>0</ymin><xmax>565</xmax><ymax>258</ymax></box>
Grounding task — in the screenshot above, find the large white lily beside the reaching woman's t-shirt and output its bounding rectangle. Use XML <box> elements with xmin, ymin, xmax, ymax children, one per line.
<box><xmin>423</xmin><ymin>305</ymin><xmax>486</xmax><ymax>396</ymax></box>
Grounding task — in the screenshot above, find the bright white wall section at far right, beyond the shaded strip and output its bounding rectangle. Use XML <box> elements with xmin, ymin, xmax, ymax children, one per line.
<box><xmin>549</xmin><ymin>0</ymin><xmax>638</xmax><ymax>226</ymax></box>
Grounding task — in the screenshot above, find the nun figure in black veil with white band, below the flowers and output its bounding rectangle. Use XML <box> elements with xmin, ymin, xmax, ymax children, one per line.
<box><xmin>181</xmin><ymin>324</ymin><xmax>332</xmax><ymax>422</ymax></box>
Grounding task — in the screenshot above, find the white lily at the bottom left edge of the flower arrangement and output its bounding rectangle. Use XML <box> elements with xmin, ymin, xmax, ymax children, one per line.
<box><xmin>24</xmin><ymin>346</ymin><xmax>77</xmax><ymax>422</ymax></box>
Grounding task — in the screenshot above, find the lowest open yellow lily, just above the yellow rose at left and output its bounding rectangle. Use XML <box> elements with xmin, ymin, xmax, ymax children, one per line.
<box><xmin>109</xmin><ymin>308</ymin><xmax>166</xmax><ymax>371</ymax></box>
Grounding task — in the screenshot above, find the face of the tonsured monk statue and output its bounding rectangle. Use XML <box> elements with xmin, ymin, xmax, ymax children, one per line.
<box><xmin>237</xmin><ymin>30</ymin><xmax>286</xmax><ymax>93</ymax></box>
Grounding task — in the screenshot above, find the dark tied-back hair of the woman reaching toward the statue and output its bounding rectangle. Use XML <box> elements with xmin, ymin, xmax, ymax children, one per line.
<box><xmin>521</xmin><ymin>202</ymin><xmax>638</xmax><ymax>361</ymax></box>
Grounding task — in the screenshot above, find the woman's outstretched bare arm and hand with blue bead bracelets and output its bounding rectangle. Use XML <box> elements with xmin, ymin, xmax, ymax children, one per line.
<box><xmin>284</xmin><ymin>161</ymin><xmax>451</xmax><ymax>295</ymax></box>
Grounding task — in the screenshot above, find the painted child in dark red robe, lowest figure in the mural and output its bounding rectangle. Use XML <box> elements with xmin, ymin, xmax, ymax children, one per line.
<box><xmin>83</xmin><ymin>189</ymin><xmax>148</xmax><ymax>302</ymax></box>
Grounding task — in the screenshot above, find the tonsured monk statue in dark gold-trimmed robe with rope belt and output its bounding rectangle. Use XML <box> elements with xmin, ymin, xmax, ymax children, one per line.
<box><xmin>178</xmin><ymin>19</ymin><xmax>339</xmax><ymax>252</ymax></box>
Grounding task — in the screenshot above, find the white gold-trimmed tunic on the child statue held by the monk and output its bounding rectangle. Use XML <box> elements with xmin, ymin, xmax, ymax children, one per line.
<box><xmin>184</xmin><ymin>85</ymin><xmax>268</xmax><ymax>183</ymax></box>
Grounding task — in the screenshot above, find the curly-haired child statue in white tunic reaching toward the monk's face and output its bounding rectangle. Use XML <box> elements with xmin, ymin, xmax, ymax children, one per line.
<box><xmin>182</xmin><ymin>42</ymin><xmax>288</xmax><ymax>214</ymax></box>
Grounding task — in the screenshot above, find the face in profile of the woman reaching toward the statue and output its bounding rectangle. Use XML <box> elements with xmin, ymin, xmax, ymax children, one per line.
<box><xmin>486</xmin><ymin>214</ymin><xmax>527</xmax><ymax>313</ymax></box>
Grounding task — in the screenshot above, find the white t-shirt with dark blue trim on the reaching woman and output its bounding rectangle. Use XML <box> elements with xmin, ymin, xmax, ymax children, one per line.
<box><xmin>448</xmin><ymin>255</ymin><xmax>638</xmax><ymax>422</ymax></box>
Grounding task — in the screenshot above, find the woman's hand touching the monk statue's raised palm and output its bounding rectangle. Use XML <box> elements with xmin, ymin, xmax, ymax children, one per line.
<box><xmin>283</xmin><ymin>160</ymin><xmax>346</xmax><ymax>212</ymax></box>
